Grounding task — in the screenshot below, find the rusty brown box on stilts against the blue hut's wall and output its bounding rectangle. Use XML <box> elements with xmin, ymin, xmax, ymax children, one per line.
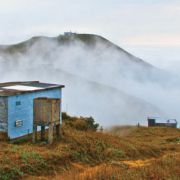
<box><xmin>33</xmin><ymin>97</ymin><xmax>60</xmax><ymax>144</ymax></box>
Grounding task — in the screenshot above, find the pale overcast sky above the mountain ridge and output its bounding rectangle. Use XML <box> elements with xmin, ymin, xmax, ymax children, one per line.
<box><xmin>0</xmin><ymin>0</ymin><xmax>180</xmax><ymax>68</ymax></box>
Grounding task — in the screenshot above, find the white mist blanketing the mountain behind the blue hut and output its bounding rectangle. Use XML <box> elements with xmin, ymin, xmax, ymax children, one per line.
<box><xmin>0</xmin><ymin>33</ymin><xmax>180</xmax><ymax>126</ymax></box>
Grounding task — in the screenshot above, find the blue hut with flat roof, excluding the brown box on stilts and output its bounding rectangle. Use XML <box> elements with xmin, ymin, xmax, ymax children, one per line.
<box><xmin>0</xmin><ymin>81</ymin><xmax>64</xmax><ymax>139</ymax></box>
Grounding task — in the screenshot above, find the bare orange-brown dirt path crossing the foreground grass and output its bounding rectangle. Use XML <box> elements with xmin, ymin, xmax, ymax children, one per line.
<box><xmin>23</xmin><ymin>153</ymin><xmax>179</xmax><ymax>180</ymax></box>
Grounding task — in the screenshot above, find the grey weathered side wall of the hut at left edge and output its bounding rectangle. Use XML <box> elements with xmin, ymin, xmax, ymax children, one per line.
<box><xmin>0</xmin><ymin>97</ymin><xmax>8</xmax><ymax>132</ymax></box>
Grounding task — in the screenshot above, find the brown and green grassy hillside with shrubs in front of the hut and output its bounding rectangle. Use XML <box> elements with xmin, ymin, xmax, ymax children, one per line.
<box><xmin>0</xmin><ymin>116</ymin><xmax>180</xmax><ymax>180</ymax></box>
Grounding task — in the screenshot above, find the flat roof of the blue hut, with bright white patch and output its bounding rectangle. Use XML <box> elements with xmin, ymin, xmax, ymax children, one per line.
<box><xmin>0</xmin><ymin>81</ymin><xmax>65</xmax><ymax>96</ymax></box>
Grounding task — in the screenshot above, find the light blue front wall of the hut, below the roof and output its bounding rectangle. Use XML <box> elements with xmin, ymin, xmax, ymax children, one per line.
<box><xmin>8</xmin><ymin>88</ymin><xmax>61</xmax><ymax>139</ymax></box>
